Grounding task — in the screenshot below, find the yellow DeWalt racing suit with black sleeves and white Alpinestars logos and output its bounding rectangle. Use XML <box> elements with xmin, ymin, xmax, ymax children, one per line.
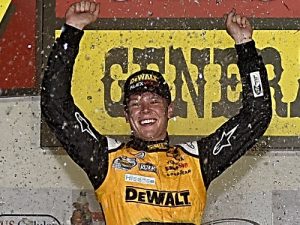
<box><xmin>41</xmin><ymin>25</ymin><xmax>272</xmax><ymax>225</ymax></box>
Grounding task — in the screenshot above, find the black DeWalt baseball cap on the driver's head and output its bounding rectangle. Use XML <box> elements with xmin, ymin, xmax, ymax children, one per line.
<box><xmin>123</xmin><ymin>70</ymin><xmax>171</xmax><ymax>106</ymax></box>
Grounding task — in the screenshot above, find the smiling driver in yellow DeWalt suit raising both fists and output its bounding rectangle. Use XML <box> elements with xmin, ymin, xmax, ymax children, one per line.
<box><xmin>41</xmin><ymin>1</ymin><xmax>272</xmax><ymax>225</ymax></box>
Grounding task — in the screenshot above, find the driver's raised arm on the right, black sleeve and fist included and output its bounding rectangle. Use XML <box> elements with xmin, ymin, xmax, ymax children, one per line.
<box><xmin>198</xmin><ymin>10</ymin><xmax>272</xmax><ymax>187</ymax></box>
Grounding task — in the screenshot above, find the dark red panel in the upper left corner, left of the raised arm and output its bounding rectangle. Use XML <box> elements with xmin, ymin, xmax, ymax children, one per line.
<box><xmin>0</xmin><ymin>0</ymin><xmax>36</xmax><ymax>89</ymax></box>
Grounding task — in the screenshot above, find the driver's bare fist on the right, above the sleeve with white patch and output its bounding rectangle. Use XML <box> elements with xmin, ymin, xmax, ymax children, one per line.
<box><xmin>225</xmin><ymin>9</ymin><xmax>253</xmax><ymax>44</ymax></box>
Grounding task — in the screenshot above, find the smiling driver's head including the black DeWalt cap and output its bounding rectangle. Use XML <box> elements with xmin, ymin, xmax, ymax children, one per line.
<box><xmin>124</xmin><ymin>70</ymin><xmax>173</xmax><ymax>141</ymax></box>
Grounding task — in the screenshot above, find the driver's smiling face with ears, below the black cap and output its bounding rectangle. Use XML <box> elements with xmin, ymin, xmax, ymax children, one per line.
<box><xmin>125</xmin><ymin>92</ymin><xmax>173</xmax><ymax>141</ymax></box>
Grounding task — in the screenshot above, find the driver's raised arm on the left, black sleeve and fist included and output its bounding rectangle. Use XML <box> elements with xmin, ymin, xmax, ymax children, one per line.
<box><xmin>41</xmin><ymin>2</ymin><xmax>108</xmax><ymax>188</ymax></box>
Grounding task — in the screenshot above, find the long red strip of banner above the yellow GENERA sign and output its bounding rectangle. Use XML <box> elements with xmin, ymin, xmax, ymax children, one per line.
<box><xmin>56</xmin><ymin>0</ymin><xmax>300</xmax><ymax>18</ymax></box>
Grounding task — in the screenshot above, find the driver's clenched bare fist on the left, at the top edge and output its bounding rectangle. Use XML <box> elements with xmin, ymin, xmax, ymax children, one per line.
<box><xmin>65</xmin><ymin>1</ymin><xmax>100</xmax><ymax>30</ymax></box>
